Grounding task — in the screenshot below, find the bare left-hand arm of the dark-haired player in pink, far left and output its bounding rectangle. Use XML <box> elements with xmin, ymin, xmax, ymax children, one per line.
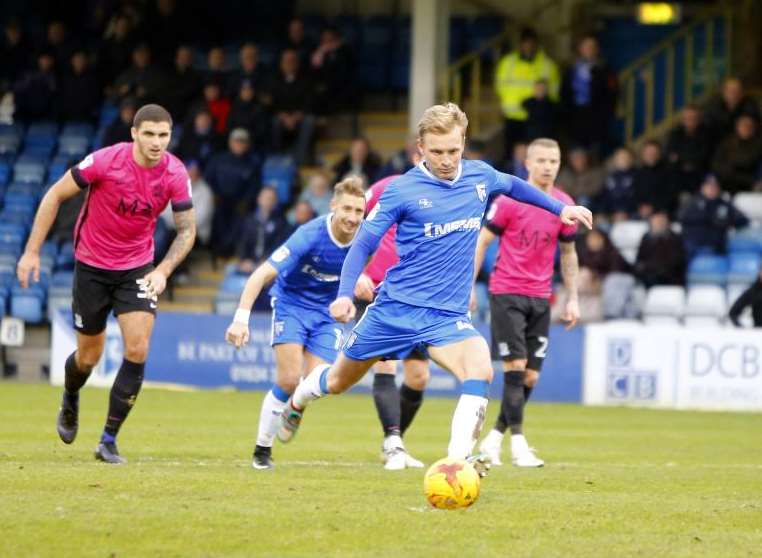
<box><xmin>16</xmin><ymin>171</ymin><xmax>82</xmax><ymax>288</ymax></box>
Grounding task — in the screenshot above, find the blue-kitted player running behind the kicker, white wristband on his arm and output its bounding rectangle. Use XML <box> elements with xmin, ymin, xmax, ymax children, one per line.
<box><xmin>225</xmin><ymin>177</ymin><xmax>365</xmax><ymax>469</ymax></box>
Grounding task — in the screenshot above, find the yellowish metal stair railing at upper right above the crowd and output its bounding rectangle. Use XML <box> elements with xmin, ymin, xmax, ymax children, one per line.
<box><xmin>618</xmin><ymin>7</ymin><xmax>734</xmax><ymax>146</ymax></box>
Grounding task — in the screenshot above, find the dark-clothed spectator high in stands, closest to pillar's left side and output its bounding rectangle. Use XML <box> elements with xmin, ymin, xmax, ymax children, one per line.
<box><xmin>310</xmin><ymin>27</ymin><xmax>357</xmax><ymax>114</ymax></box>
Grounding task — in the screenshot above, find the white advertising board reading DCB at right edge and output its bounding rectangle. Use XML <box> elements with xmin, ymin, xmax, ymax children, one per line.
<box><xmin>583</xmin><ymin>323</ymin><xmax>762</xmax><ymax>411</ymax></box>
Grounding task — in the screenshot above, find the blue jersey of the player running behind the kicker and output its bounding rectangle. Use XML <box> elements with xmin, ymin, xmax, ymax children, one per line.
<box><xmin>267</xmin><ymin>213</ymin><xmax>352</xmax><ymax>314</ymax></box>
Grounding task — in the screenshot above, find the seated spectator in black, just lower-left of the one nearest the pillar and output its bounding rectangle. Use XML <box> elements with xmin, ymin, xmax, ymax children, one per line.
<box><xmin>270</xmin><ymin>49</ymin><xmax>315</xmax><ymax>165</ymax></box>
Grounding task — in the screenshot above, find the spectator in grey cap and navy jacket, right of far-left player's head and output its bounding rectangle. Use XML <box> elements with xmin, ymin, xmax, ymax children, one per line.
<box><xmin>204</xmin><ymin>128</ymin><xmax>260</xmax><ymax>257</ymax></box>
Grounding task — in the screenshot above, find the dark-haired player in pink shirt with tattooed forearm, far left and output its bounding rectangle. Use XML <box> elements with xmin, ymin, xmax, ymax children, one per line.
<box><xmin>17</xmin><ymin>105</ymin><xmax>196</xmax><ymax>464</ymax></box>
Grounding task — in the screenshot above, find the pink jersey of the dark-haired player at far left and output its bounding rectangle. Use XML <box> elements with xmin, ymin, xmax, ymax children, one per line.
<box><xmin>71</xmin><ymin>143</ymin><xmax>193</xmax><ymax>270</ymax></box>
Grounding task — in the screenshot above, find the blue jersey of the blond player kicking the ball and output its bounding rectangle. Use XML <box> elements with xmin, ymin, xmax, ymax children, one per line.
<box><xmin>362</xmin><ymin>160</ymin><xmax>563</xmax><ymax>313</ymax></box>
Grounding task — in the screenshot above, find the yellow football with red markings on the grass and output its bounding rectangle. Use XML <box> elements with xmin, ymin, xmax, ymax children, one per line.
<box><xmin>423</xmin><ymin>457</ymin><xmax>481</xmax><ymax>510</ymax></box>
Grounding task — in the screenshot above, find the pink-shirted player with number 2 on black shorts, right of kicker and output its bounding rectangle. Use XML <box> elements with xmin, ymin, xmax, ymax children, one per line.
<box><xmin>472</xmin><ymin>139</ymin><xmax>579</xmax><ymax>467</ymax></box>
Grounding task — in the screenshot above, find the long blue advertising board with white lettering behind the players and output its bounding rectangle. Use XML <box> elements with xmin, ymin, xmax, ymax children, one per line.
<box><xmin>50</xmin><ymin>309</ymin><xmax>584</xmax><ymax>403</ymax></box>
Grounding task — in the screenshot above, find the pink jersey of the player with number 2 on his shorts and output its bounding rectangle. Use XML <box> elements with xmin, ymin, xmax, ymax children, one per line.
<box><xmin>485</xmin><ymin>188</ymin><xmax>577</xmax><ymax>298</ymax></box>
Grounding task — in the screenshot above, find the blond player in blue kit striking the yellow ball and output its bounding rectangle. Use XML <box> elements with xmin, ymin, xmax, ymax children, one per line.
<box><xmin>278</xmin><ymin>103</ymin><xmax>592</xmax><ymax>466</ymax></box>
